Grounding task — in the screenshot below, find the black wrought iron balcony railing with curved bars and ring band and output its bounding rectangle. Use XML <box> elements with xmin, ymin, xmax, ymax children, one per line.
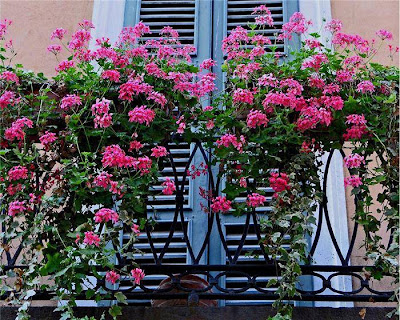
<box><xmin>3</xmin><ymin>142</ymin><xmax>393</xmax><ymax>302</ymax></box>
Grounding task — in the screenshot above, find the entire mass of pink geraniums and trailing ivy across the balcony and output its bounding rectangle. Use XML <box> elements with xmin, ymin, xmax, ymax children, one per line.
<box><xmin>0</xmin><ymin>6</ymin><xmax>398</xmax><ymax>319</ymax></box>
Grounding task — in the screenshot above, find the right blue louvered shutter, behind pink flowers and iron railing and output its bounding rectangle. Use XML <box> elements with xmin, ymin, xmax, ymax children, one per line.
<box><xmin>209</xmin><ymin>0</ymin><xmax>309</xmax><ymax>305</ymax></box>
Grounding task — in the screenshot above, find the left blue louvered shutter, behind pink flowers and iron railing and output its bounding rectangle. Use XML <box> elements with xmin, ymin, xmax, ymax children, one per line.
<box><xmin>121</xmin><ymin>0</ymin><xmax>212</xmax><ymax>303</ymax></box>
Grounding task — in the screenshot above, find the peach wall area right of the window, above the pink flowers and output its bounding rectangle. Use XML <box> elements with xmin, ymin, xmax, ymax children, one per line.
<box><xmin>330</xmin><ymin>0</ymin><xmax>399</xmax><ymax>65</ymax></box>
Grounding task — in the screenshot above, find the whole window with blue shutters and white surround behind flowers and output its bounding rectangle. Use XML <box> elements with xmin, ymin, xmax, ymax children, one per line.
<box><xmin>93</xmin><ymin>0</ymin><xmax>351</xmax><ymax>306</ymax></box>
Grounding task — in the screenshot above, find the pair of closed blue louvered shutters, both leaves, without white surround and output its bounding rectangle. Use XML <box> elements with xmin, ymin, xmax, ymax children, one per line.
<box><xmin>121</xmin><ymin>0</ymin><xmax>304</xmax><ymax>305</ymax></box>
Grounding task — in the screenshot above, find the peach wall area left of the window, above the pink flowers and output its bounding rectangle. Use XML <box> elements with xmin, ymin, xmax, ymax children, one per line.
<box><xmin>0</xmin><ymin>0</ymin><xmax>93</xmax><ymax>76</ymax></box>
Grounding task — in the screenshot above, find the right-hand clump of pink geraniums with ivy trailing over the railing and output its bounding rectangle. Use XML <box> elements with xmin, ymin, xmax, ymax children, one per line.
<box><xmin>198</xmin><ymin>6</ymin><xmax>399</xmax><ymax>317</ymax></box>
